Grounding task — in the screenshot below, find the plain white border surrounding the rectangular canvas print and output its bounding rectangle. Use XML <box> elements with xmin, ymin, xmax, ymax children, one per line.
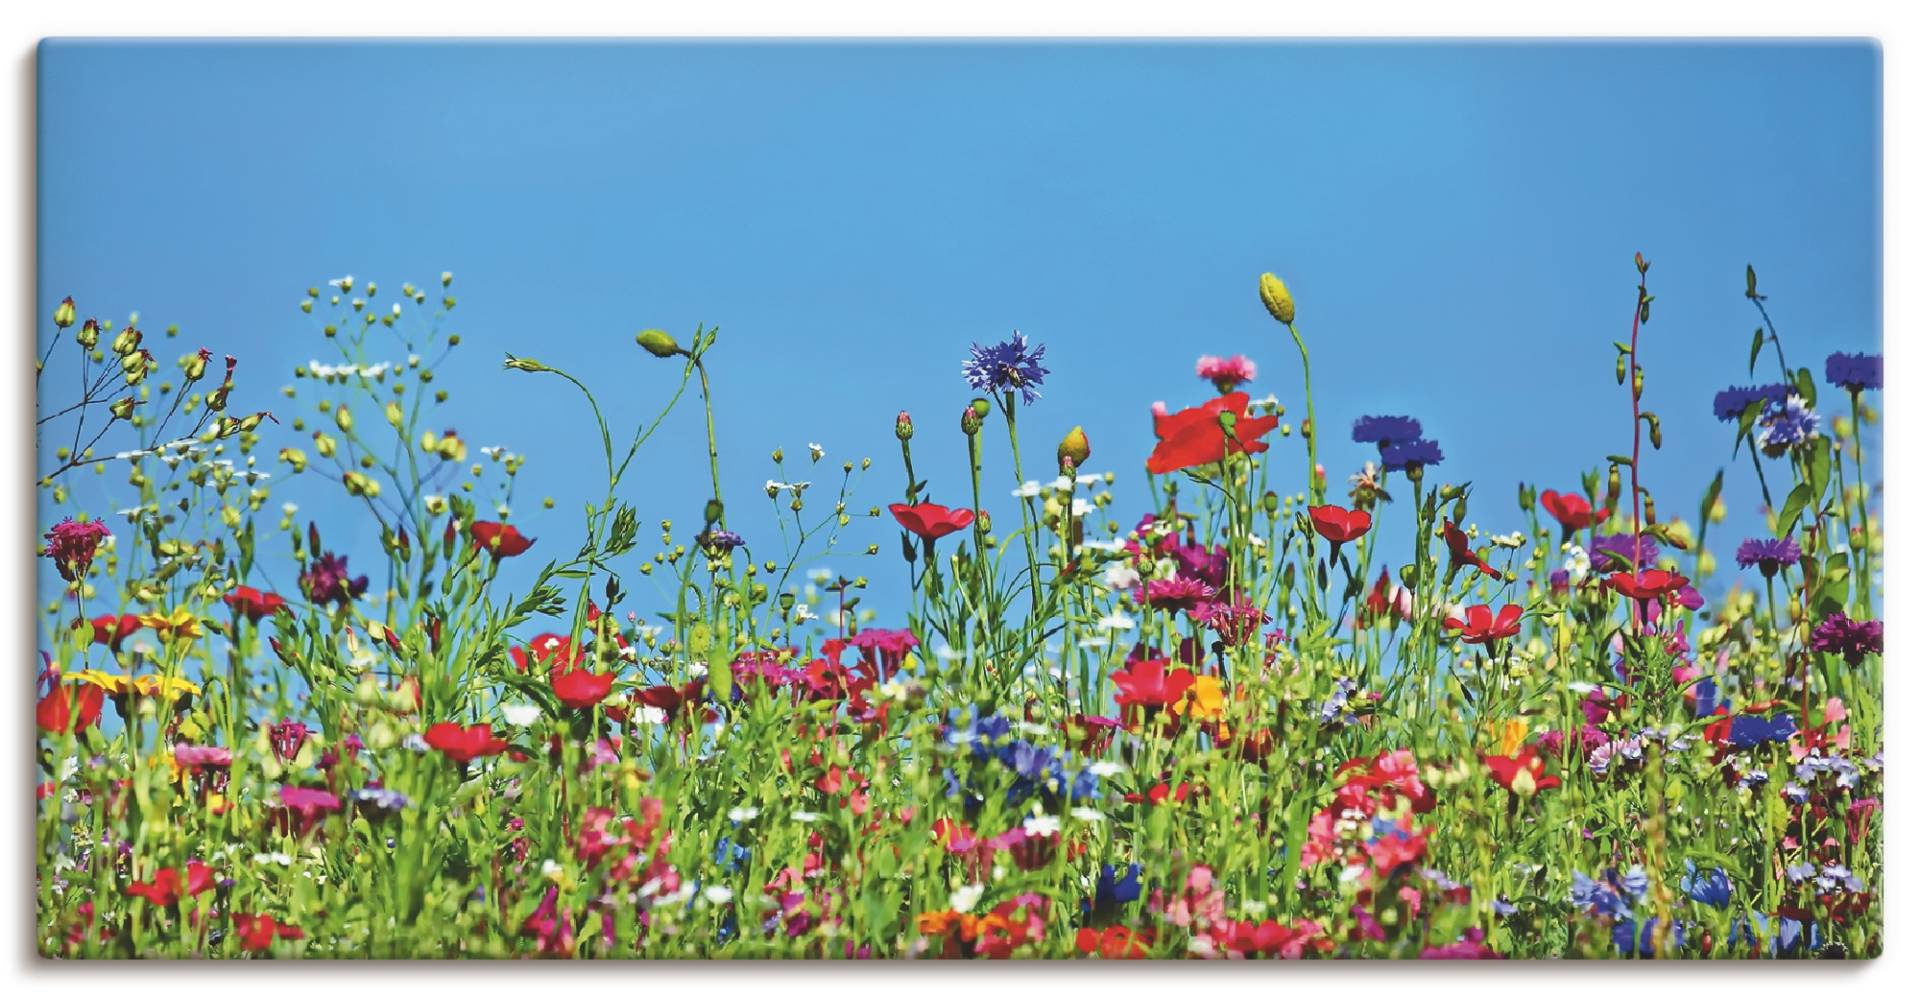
<box><xmin>0</xmin><ymin>0</ymin><xmax>1920</xmax><ymax>996</ymax></box>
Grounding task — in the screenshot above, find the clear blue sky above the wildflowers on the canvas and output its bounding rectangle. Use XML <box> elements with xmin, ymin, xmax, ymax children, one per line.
<box><xmin>38</xmin><ymin>42</ymin><xmax>1882</xmax><ymax>621</ymax></box>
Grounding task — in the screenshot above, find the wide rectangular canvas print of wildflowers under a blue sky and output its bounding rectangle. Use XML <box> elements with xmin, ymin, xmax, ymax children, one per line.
<box><xmin>30</xmin><ymin>40</ymin><xmax>1887</xmax><ymax>960</ymax></box>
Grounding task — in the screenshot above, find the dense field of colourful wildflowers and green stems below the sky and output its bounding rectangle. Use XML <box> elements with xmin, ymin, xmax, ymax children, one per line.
<box><xmin>35</xmin><ymin>255</ymin><xmax>1884</xmax><ymax>960</ymax></box>
